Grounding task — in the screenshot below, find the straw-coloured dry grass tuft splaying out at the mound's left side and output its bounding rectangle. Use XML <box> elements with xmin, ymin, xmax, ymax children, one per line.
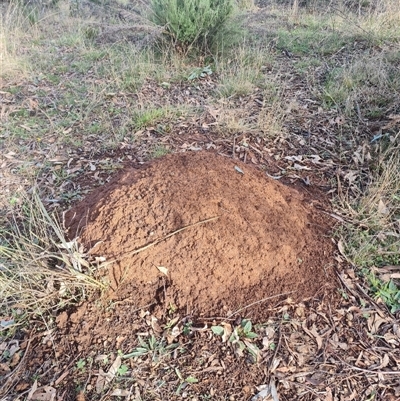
<box><xmin>0</xmin><ymin>192</ymin><xmax>106</xmax><ymax>316</ymax></box>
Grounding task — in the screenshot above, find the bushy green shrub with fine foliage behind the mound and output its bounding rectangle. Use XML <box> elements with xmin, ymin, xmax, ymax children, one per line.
<box><xmin>150</xmin><ymin>0</ymin><xmax>233</xmax><ymax>51</ymax></box>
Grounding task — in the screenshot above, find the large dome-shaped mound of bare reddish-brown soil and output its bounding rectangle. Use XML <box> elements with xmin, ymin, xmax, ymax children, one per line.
<box><xmin>66</xmin><ymin>152</ymin><xmax>334</xmax><ymax>316</ymax></box>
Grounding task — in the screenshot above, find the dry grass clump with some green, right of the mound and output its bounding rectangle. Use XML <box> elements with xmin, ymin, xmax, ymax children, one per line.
<box><xmin>342</xmin><ymin>133</ymin><xmax>400</xmax><ymax>306</ymax></box>
